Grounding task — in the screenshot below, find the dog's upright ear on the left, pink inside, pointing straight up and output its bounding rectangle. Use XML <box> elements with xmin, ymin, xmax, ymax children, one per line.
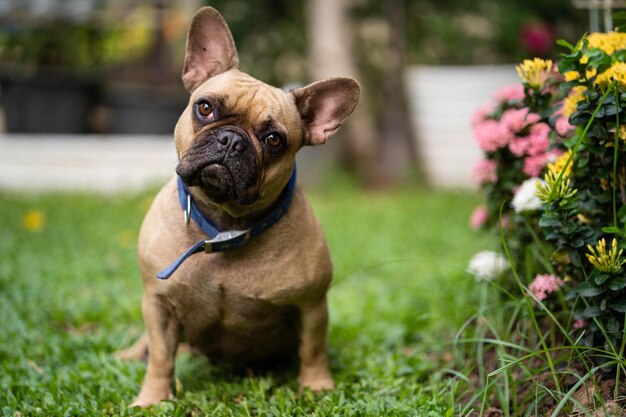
<box><xmin>183</xmin><ymin>7</ymin><xmax>239</xmax><ymax>92</ymax></box>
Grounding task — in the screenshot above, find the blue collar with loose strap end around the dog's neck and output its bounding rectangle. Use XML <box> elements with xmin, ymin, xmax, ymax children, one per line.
<box><xmin>157</xmin><ymin>167</ymin><xmax>296</xmax><ymax>279</ymax></box>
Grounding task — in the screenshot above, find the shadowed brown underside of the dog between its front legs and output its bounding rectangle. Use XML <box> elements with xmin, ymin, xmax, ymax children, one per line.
<box><xmin>164</xmin><ymin>254</ymin><xmax>299</xmax><ymax>360</ymax></box>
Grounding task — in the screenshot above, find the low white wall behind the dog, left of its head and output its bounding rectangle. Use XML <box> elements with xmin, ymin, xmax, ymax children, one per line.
<box><xmin>0</xmin><ymin>135</ymin><xmax>177</xmax><ymax>193</ymax></box>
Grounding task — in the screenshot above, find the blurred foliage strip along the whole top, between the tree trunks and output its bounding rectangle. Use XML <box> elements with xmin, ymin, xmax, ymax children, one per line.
<box><xmin>0</xmin><ymin>0</ymin><xmax>587</xmax><ymax>77</ymax></box>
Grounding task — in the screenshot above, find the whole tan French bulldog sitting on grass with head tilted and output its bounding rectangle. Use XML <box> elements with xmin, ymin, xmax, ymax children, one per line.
<box><xmin>119</xmin><ymin>7</ymin><xmax>360</xmax><ymax>406</ymax></box>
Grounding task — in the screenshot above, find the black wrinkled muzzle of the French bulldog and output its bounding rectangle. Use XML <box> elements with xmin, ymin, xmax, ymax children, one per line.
<box><xmin>176</xmin><ymin>128</ymin><xmax>260</xmax><ymax>205</ymax></box>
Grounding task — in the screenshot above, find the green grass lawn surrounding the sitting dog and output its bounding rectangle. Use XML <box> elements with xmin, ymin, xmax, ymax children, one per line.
<box><xmin>0</xmin><ymin>180</ymin><xmax>495</xmax><ymax>416</ymax></box>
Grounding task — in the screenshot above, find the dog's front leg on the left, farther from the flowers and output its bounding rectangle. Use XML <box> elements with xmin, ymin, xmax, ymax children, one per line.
<box><xmin>132</xmin><ymin>295</ymin><xmax>180</xmax><ymax>407</ymax></box>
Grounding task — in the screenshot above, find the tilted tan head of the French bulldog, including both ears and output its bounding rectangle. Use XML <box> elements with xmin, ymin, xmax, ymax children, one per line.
<box><xmin>175</xmin><ymin>7</ymin><xmax>360</xmax><ymax>216</ymax></box>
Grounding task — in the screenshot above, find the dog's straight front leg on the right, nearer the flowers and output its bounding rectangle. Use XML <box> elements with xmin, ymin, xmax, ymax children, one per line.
<box><xmin>298</xmin><ymin>297</ymin><xmax>335</xmax><ymax>392</ymax></box>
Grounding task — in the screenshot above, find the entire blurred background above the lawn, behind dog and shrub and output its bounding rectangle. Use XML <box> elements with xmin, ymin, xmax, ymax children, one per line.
<box><xmin>0</xmin><ymin>0</ymin><xmax>590</xmax><ymax>187</ymax></box>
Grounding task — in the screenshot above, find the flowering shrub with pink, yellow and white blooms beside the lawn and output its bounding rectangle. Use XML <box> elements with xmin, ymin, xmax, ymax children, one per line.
<box><xmin>471</xmin><ymin>32</ymin><xmax>626</xmax><ymax>352</ymax></box>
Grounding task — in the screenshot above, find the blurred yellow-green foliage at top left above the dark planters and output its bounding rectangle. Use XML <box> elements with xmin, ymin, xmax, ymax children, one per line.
<box><xmin>0</xmin><ymin>6</ymin><xmax>156</xmax><ymax>72</ymax></box>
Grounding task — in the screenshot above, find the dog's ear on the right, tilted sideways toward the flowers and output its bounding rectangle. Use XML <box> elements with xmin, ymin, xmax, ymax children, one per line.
<box><xmin>291</xmin><ymin>78</ymin><xmax>361</xmax><ymax>145</ymax></box>
